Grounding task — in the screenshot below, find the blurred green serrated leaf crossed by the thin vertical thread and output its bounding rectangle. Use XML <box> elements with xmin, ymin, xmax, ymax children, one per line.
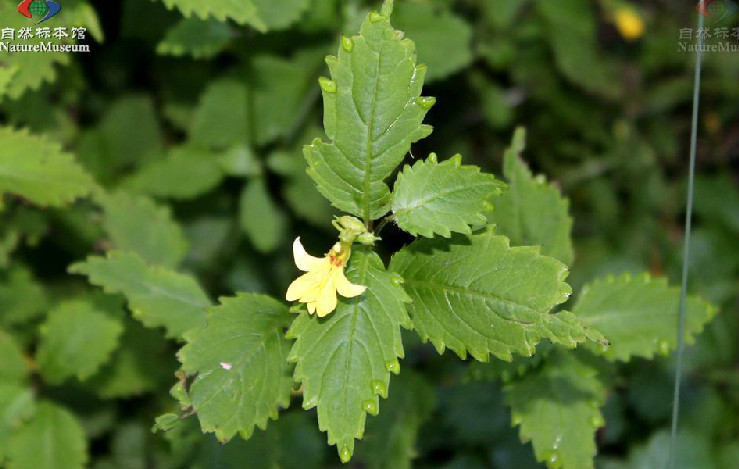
<box><xmin>572</xmin><ymin>273</ymin><xmax>717</xmax><ymax>361</ymax></box>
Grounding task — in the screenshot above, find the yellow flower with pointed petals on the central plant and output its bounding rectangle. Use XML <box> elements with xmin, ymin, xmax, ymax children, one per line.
<box><xmin>285</xmin><ymin>238</ymin><xmax>367</xmax><ymax>318</ymax></box>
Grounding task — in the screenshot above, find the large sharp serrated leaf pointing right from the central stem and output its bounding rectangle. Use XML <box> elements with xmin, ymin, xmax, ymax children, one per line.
<box><xmin>390</xmin><ymin>230</ymin><xmax>588</xmax><ymax>361</ymax></box>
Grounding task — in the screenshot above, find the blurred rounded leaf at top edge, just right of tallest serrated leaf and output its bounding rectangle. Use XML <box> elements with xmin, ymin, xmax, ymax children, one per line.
<box><xmin>393</xmin><ymin>2</ymin><xmax>472</xmax><ymax>81</ymax></box>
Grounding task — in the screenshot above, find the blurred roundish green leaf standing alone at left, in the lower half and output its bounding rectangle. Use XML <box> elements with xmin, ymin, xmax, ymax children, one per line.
<box><xmin>36</xmin><ymin>300</ymin><xmax>123</xmax><ymax>384</ymax></box>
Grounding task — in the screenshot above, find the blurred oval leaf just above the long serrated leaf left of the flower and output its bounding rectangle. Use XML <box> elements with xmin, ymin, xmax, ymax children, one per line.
<box><xmin>101</xmin><ymin>191</ymin><xmax>187</xmax><ymax>267</ymax></box>
